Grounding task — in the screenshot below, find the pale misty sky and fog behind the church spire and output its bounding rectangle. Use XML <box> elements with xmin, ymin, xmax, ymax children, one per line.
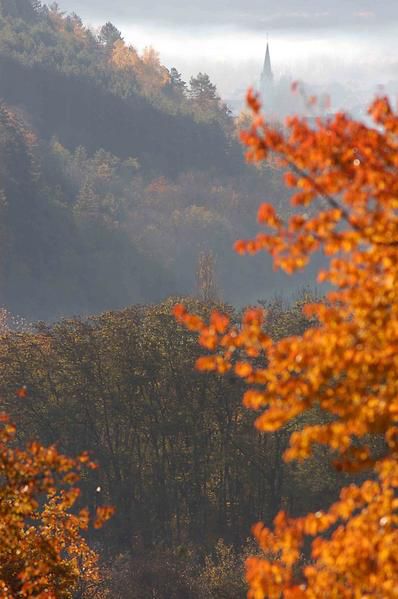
<box><xmin>60</xmin><ymin>0</ymin><xmax>398</xmax><ymax>102</ymax></box>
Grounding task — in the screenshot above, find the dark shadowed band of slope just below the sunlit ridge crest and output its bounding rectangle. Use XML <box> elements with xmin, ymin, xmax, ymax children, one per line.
<box><xmin>0</xmin><ymin>55</ymin><xmax>242</xmax><ymax>177</ymax></box>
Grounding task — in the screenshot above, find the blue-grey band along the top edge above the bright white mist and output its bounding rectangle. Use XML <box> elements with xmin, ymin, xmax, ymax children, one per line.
<box><xmin>61</xmin><ymin>0</ymin><xmax>398</xmax><ymax>31</ymax></box>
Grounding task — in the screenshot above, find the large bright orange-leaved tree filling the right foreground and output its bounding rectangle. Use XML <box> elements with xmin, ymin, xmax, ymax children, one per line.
<box><xmin>175</xmin><ymin>92</ymin><xmax>398</xmax><ymax>599</ymax></box>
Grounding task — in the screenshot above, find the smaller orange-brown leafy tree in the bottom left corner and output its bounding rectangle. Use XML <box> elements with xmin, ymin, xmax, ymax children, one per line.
<box><xmin>0</xmin><ymin>406</ymin><xmax>113</xmax><ymax>599</ymax></box>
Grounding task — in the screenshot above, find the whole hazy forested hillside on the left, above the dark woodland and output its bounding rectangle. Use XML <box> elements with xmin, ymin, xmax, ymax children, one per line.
<box><xmin>0</xmin><ymin>0</ymin><xmax>300</xmax><ymax>320</ymax></box>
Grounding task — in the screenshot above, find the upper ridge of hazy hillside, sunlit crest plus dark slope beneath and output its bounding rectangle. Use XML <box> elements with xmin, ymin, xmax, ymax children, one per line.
<box><xmin>0</xmin><ymin>0</ymin><xmax>242</xmax><ymax>176</ymax></box>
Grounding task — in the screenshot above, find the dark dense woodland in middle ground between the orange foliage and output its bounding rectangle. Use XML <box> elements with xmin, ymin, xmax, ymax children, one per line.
<box><xmin>0</xmin><ymin>295</ymin><xmax>358</xmax><ymax>599</ymax></box>
